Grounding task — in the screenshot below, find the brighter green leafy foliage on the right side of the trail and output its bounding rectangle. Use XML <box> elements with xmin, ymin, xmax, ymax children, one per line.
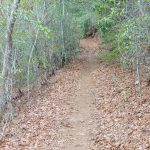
<box><xmin>95</xmin><ymin>0</ymin><xmax>150</xmax><ymax>65</ymax></box>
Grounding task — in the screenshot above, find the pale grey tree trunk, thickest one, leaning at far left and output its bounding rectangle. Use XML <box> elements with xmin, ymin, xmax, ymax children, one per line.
<box><xmin>0</xmin><ymin>0</ymin><xmax>20</xmax><ymax>115</ymax></box>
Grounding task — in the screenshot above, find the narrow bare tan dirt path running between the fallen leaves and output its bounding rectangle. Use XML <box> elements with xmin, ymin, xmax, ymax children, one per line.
<box><xmin>61</xmin><ymin>38</ymin><xmax>99</xmax><ymax>150</ymax></box>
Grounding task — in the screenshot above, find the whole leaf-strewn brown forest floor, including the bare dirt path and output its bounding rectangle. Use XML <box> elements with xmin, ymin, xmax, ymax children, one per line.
<box><xmin>0</xmin><ymin>37</ymin><xmax>150</xmax><ymax>150</ymax></box>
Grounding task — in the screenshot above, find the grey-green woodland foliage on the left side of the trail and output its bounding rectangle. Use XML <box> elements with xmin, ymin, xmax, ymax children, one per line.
<box><xmin>0</xmin><ymin>0</ymin><xmax>97</xmax><ymax>87</ymax></box>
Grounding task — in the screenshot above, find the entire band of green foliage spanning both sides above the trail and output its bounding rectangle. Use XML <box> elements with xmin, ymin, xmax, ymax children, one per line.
<box><xmin>0</xmin><ymin>0</ymin><xmax>150</xmax><ymax>91</ymax></box>
